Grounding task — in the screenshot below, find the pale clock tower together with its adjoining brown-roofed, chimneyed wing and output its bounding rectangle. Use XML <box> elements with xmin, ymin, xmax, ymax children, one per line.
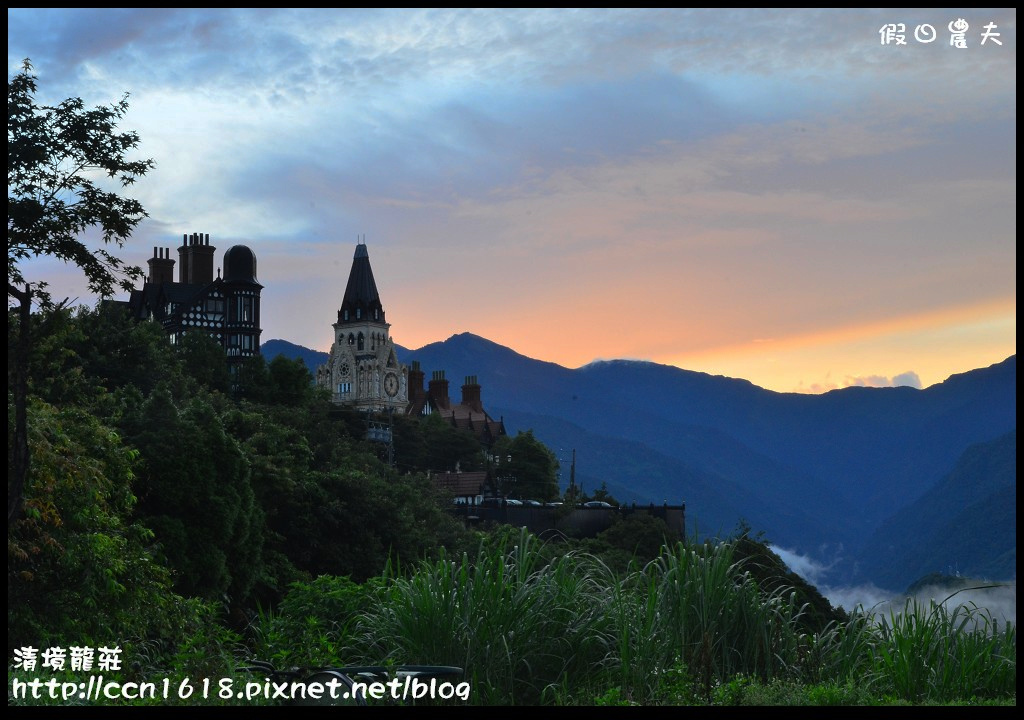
<box><xmin>316</xmin><ymin>243</ymin><xmax>506</xmax><ymax>447</ymax></box>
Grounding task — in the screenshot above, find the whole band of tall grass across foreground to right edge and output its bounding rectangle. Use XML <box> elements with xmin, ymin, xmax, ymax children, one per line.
<box><xmin>258</xmin><ymin>531</ymin><xmax>1017</xmax><ymax>705</ymax></box>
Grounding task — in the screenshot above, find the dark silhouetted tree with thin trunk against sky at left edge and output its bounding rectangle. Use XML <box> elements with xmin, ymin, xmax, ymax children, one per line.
<box><xmin>7</xmin><ymin>59</ymin><xmax>154</xmax><ymax>523</ymax></box>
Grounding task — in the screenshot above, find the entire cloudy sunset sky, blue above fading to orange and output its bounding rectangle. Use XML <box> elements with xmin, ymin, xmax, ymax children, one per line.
<box><xmin>7</xmin><ymin>8</ymin><xmax>1017</xmax><ymax>392</ymax></box>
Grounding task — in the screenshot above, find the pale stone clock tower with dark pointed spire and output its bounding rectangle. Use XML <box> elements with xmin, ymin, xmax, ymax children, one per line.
<box><xmin>316</xmin><ymin>243</ymin><xmax>409</xmax><ymax>413</ymax></box>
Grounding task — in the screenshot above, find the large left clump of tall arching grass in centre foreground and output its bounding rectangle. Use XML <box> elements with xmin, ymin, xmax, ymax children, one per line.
<box><xmin>364</xmin><ymin>532</ymin><xmax>611</xmax><ymax>705</ymax></box>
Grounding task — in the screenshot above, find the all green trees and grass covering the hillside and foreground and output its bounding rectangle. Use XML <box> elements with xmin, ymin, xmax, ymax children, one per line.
<box><xmin>7</xmin><ymin>309</ymin><xmax>1016</xmax><ymax>705</ymax></box>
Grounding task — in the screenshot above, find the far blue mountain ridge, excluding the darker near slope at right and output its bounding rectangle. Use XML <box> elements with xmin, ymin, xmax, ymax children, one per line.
<box><xmin>264</xmin><ymin>333</ymin><xmax>1016</xmax><ymax>587</ymax></box>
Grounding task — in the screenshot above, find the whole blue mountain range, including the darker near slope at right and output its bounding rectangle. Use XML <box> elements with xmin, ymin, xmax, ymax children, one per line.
<box><xmin>262</xmin><ymin>333</ymin><xmax>1017</xmax><ymax>591</ymax></box>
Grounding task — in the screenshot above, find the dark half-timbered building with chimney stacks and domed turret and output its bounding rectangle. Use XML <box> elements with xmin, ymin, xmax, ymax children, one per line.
<box><xmin>117</xmin><ymin>232</ymin><xmax>263</xmax><ymax>366</ymax></box>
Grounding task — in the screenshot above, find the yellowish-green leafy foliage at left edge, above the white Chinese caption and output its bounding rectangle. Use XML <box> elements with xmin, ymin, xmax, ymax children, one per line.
<box><xmin>7</xmin><ymin>400</ymin><xmax>180</xmax><ymax>647</ymax></box>
